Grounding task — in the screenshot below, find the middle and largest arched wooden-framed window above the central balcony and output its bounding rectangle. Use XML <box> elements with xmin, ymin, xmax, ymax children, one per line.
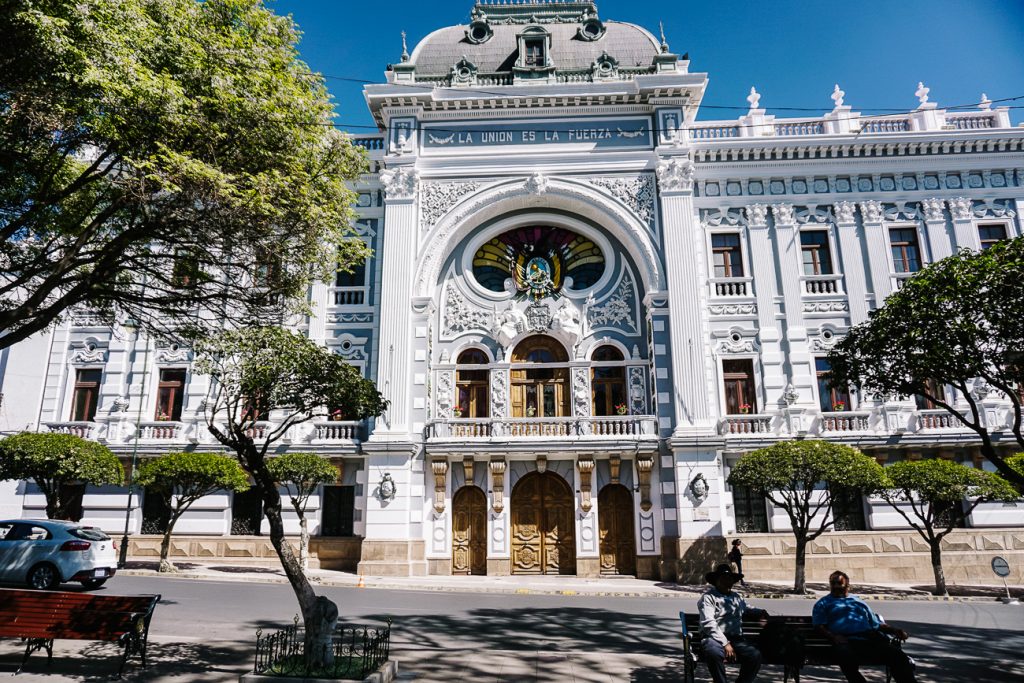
<box><xmin>512</xmin><ymin>336</ymin><xmax>571</xmax><ymax>418</ymax></box>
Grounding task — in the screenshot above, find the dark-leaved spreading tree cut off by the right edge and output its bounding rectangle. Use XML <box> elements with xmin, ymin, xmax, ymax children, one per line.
<box><xmin>828</xmin><ymin>238</ymin><xmax>1024</xmax><ymax>487</ymax></box>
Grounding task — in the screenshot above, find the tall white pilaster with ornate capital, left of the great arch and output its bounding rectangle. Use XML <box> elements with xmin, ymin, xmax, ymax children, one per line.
<box><xmin>371</xmin><ymin>165</ymin><xmax>419</xmax><ymax>440</ymax></box>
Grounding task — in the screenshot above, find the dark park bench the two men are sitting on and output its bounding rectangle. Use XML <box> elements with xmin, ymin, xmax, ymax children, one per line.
<box><xmin>679</xmin><ymin>612</ymin><xmax>898</xmax><ymax>683</ymax></box>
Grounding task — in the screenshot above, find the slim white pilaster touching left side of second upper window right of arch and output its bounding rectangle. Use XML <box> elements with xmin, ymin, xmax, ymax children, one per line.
<box><xmin>771</xmin><ymin>204</ymin><xmax>814</xmax><ymax>405</ymax></box>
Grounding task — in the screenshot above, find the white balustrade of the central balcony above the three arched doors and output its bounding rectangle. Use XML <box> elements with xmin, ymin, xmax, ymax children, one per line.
<box><xmin>427</xmin><ymin>415</ymin><xmax>657</xmax><ymax>440</ymax></box>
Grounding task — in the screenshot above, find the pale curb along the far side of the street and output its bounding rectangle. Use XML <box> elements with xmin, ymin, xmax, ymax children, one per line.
<box><xmin>118</xmin><ymin>569</ymin><xmax>999</xmax><ymax>602</ymax></box>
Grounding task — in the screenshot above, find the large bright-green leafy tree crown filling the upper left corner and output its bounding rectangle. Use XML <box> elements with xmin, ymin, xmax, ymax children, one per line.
<box><xmin>0</xmin><ymin>0</ymin><xmax>369</xmax><ymax>348</ymax></box>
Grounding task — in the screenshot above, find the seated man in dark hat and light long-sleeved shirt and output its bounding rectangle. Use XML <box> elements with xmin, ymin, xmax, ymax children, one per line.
<box><xmin>697</xmin><ymin>564</ymin><xmax>768</xmax><ymax>683</ymax></box>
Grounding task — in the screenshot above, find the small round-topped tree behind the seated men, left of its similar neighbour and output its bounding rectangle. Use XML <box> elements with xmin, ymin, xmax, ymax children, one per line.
<box><xmin>729</xmin><ymin>440</ymin><xmax>884</xmax><ymax>593</ymax></box>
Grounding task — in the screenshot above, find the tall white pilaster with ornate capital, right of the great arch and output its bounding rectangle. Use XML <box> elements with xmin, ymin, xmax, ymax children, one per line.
<box><xmin>657</xmin><ymin>153</ymin><xmax>715</xmax><ymax>434</ymax></box>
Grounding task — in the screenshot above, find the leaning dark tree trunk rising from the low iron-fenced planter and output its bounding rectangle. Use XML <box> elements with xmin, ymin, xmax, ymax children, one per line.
<box><xmin>246</xmin><ymin>445</ymin><xmax>338</xmax><ymax>673</ymax></box>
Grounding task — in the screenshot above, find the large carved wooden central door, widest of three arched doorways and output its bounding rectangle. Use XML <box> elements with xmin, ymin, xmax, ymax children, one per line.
<box><xmin>511</xmin><ymin>472</ymin><xmax>575</xmax><ymax>574</ymax></box>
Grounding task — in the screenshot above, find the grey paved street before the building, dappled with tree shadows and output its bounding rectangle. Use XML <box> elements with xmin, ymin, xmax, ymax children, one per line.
<box><xmin>0</xmin><ymin>577</ymin><xmax>1024</xmax><ymax>683</ymax></box>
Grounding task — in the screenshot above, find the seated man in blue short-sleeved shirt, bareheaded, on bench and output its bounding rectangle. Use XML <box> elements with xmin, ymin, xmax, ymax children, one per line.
<box><xmin>811</xmin><ymin>571</ymin><xmax>915</xmax><ymax>683</ymax></box>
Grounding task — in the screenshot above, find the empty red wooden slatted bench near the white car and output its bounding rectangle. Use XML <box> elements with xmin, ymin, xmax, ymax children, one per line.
<box><xmin>0</xmin><ymin>589</ymin><xmax>160</xmax><ymax>677</ymax></box>
